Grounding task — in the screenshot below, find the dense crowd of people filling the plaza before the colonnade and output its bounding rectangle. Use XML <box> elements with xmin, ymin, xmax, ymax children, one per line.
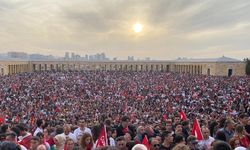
<box><xmin>0</xmin><ymin>71</ymin><xmax>250</xmax><ymax>150</ymax></box>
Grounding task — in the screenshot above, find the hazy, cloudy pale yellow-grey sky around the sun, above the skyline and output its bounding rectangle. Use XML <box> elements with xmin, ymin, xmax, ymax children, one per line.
<box><xmin>0</xmin><ymin>0</ymin><xmax>250</xmax><ymax>60</ymax></box>
